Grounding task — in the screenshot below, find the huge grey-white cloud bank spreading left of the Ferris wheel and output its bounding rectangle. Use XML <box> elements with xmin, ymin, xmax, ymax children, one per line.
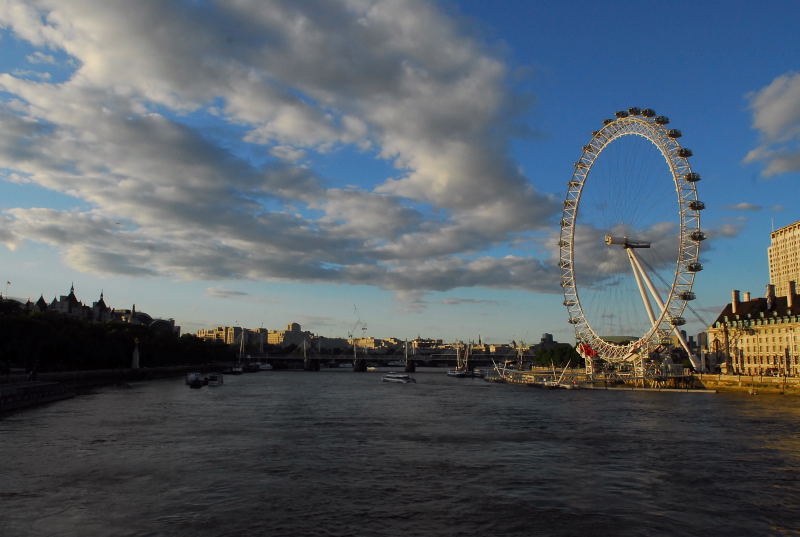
<box><xmin>0</xmin><ymin>0</ymin><xmax>559</xmax><ymax>302</ymax></box>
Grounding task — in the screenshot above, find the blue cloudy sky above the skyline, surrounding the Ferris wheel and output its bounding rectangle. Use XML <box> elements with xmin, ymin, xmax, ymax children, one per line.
<box><xmin>0</xmin><ymin>0</ymin><xmax>800</xmax><ymax>342</ymax></box>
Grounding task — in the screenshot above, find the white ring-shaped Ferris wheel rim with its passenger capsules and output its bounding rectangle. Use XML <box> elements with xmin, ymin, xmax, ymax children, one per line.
<box><xmin>559</xmin><ymin>108</ymin><xmax>704</xmax><ymax>362</ymax></box>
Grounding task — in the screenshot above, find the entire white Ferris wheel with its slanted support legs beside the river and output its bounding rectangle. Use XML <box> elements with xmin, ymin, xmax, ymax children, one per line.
<box><xmin>559</xmin><ymin>108</ymin><xmax>706</xmax><ymax>374</ymax></box>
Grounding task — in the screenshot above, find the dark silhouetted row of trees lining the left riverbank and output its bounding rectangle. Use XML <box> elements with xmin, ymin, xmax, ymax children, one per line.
<box><xmin>0</xmin><ymin>302</ymin><xmax>235</xmax><ymax>372</ymax></box>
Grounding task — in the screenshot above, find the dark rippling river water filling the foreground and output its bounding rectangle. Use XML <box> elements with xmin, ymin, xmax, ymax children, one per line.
<box><xmin>0</xmin><ymin>371</ymin><xmax>800</xmax><ymax>537</ymax></box>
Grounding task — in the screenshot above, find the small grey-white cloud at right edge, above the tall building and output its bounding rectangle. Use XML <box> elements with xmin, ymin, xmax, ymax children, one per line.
<box><xmin>744</xmin><ymin>72</ymin><xmax>800</xmax><ymax>177</ymax></box>
